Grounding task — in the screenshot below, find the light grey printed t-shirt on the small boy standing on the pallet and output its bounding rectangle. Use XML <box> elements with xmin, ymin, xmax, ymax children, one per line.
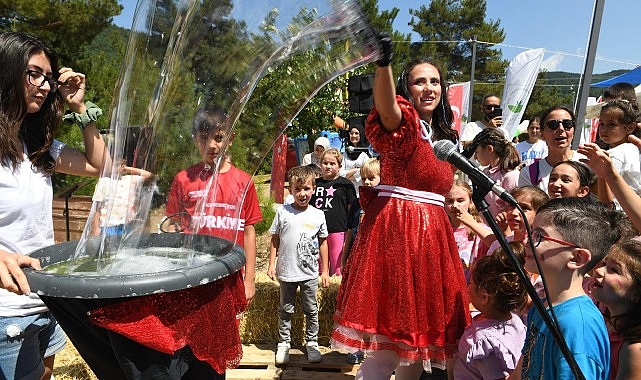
<box><xmin>269</xmin><ymin>204</ymin><xmax>328</xmax><ymax>282</ymax></box>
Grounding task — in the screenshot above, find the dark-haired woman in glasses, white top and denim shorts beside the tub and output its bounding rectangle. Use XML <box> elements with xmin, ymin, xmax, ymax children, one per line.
<box><xmin>0</xmin><ymin>32</ymin><xmax>106</xmax><ymax>379</ymax></box>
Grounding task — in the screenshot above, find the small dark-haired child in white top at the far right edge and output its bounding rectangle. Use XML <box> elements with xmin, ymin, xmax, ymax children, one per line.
<box><xmin>597</xmin><ymin>99</ymin><xmax>641</xmax><ymax>206</ymax></box>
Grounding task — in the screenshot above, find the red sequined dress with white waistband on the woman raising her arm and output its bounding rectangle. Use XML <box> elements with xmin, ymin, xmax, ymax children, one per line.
<box><xmin>332</xmin><ymin>97</ymin><xmax>470</xmax><ymax>369</ymax></box>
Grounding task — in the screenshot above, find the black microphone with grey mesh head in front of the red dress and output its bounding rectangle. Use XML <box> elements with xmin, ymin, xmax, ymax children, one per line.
<box><xmin>434</xmin><ymin>140</ymin><xmax>517</xmax><ymax>206</ymax></box>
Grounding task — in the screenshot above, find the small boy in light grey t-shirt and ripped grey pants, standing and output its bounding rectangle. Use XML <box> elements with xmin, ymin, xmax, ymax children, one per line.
<box><xmin>267</xmin><ymin>166</ymin><xmax>329</xmax><ymax>364</ymax></box>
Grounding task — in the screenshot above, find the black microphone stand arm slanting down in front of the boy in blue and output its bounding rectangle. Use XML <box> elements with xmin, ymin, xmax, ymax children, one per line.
<box><xmin>472</xmin><ymin>184</ymin><xmax>585</xmax><ymax>380</ymax></box>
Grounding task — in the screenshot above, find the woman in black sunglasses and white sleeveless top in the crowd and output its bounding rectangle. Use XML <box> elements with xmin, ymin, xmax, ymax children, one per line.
<box><xmin>519</xmin><ymin>106</ymin><xmax>585</xmax><ymax>191</ymax></box>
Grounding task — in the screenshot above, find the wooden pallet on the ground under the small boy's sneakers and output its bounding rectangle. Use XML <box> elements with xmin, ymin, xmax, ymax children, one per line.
<box><xmin>226</xmin><ymin>344</ymin><xmax>358</xmax><ymax>380</ymax></box>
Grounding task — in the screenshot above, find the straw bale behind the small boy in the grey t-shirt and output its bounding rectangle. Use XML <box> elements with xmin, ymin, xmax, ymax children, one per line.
<box><xmin>240</xmin><ymin>273</ymin><xmax>340</xmax><ymax>346</ymax></box>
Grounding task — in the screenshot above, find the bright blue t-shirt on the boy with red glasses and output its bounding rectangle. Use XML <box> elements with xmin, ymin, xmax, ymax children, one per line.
<box><xmin>521</xmin><ymin>295</ymin><xmax>610</xmax><ymax>380</ymax></box>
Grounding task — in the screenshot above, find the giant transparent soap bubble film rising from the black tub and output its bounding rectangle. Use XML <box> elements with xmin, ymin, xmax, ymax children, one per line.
<box><xmin>32</xmin><ymin>0</ymin><xmax>379</xmax><ymax>290</ymax></box>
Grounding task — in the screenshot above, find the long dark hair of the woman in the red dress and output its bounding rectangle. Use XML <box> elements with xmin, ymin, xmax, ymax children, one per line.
<box><xmin>396</xmin><ymin>59</ymin><xmax>458</xmax><ymax>143</ymax></box>
